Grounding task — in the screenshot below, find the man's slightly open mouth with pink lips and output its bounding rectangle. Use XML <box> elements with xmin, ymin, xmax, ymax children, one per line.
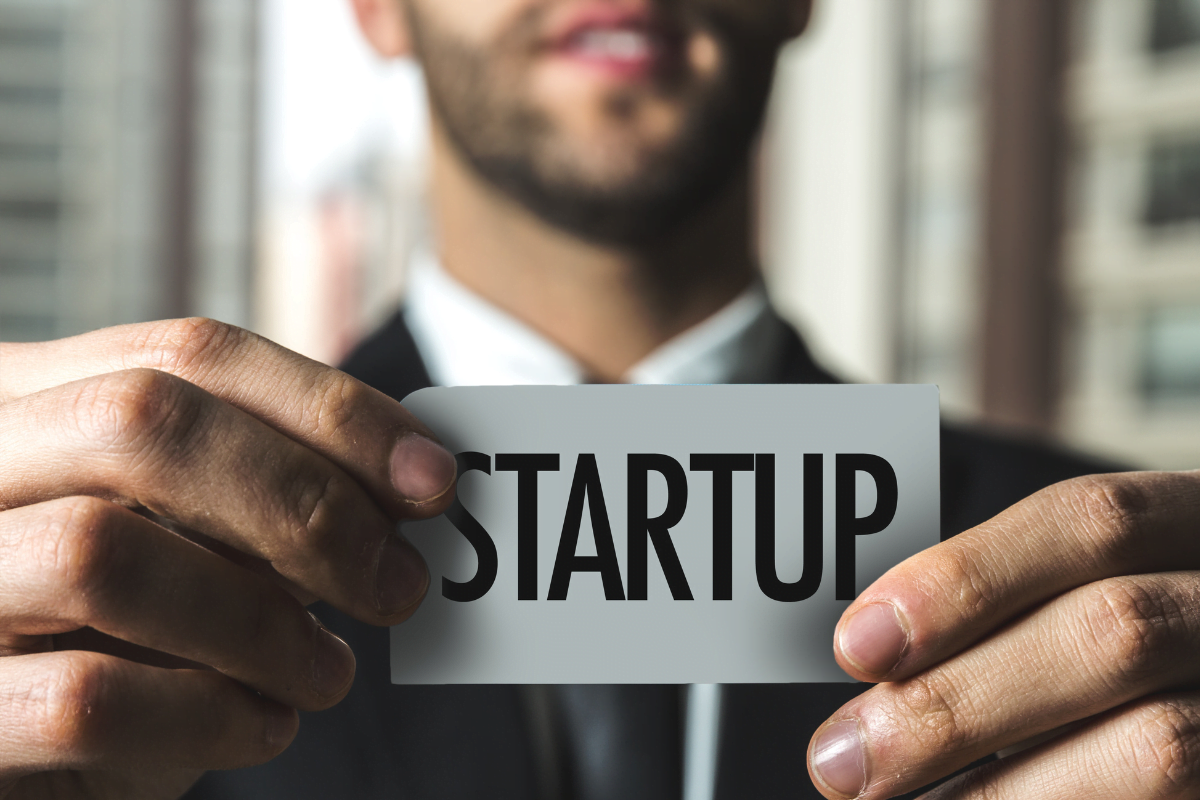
<box><xmin>550</xmin><ymin>4</ymin><xmax>683</xmax><ymax>78</ymax></box>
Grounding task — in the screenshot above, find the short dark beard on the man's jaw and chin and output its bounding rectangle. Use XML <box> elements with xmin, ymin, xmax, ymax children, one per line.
<box><xmin>407</xmin><ymin>2</ymin><xmax>782</xmax><ymax>248</ymax></box>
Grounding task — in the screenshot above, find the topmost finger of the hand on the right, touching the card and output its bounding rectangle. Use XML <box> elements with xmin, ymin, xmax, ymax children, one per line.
<box><xmin>834</xmin><ymin>473</ymin><xmax>1200</xmax><ymax>681</ymax></box>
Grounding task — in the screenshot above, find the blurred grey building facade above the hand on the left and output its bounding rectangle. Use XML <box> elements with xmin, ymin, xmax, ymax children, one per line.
<box><xmin>0</xmin><ymin>0</ymin><xmax>257</xmax><ymax>341</ymax></box>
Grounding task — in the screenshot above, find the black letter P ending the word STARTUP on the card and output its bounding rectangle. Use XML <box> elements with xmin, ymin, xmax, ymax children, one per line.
<box><xmin>834</xmin><ymin>453</ymin><xmax>899</xmax><ymax>600</ymax></box>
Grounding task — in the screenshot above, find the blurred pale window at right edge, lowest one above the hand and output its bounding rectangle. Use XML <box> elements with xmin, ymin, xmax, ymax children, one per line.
<box><xmin>1142</xmin><ymin>307</ymin><xmax>1200</xmax><ymax>405</ymax></box>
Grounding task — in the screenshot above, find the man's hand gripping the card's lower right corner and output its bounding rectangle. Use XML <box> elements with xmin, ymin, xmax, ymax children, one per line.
<box><xmin>809</xmin><ymin>473</ymin><xmax>1200</xmax><ymax>800</ymax></box>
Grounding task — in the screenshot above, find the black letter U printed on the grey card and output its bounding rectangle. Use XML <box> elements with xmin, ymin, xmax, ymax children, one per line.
<box><xmin>754</xmin><ymin>453</ymin><xmax>824</xmax><ymax>603</ymax></box>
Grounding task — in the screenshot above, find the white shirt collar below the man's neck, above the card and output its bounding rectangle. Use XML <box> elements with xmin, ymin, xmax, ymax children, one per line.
<box><xmin>404</xmin><ymin>252</ymin><xmax>787</xmax><ymax>386</ymax></box>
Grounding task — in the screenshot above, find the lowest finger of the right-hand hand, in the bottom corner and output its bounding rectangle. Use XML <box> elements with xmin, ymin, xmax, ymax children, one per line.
<box><xmin>922</xmin><ymin>692</ymin><xmax>1200</xmax><ymax>800</ymax></box>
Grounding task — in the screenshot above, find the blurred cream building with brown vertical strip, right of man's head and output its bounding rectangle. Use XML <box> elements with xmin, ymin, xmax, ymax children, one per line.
<box><xmin>766</xmin><ymin>0</ymin><xmax>1200</xmax><ymax>468</ymax></box>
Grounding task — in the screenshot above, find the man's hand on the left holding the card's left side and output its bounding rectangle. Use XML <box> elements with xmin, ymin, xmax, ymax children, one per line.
<box><xmin>0</xmin><ymin>320</ymin><xmax>455</xmax><ymax>800</ymax></box>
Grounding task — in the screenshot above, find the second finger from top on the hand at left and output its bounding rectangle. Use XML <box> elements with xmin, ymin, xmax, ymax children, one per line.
<box><xmin>0</xmin><ymin>369</ymin><xmax>428</xmax><ymax>624</ymax></box>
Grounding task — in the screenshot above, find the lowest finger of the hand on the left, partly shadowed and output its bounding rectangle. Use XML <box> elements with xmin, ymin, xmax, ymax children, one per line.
<box><xmin>0</xmin><ymin>651</ymin><xmax>299</xmax><ymax>781</ymax></box>
